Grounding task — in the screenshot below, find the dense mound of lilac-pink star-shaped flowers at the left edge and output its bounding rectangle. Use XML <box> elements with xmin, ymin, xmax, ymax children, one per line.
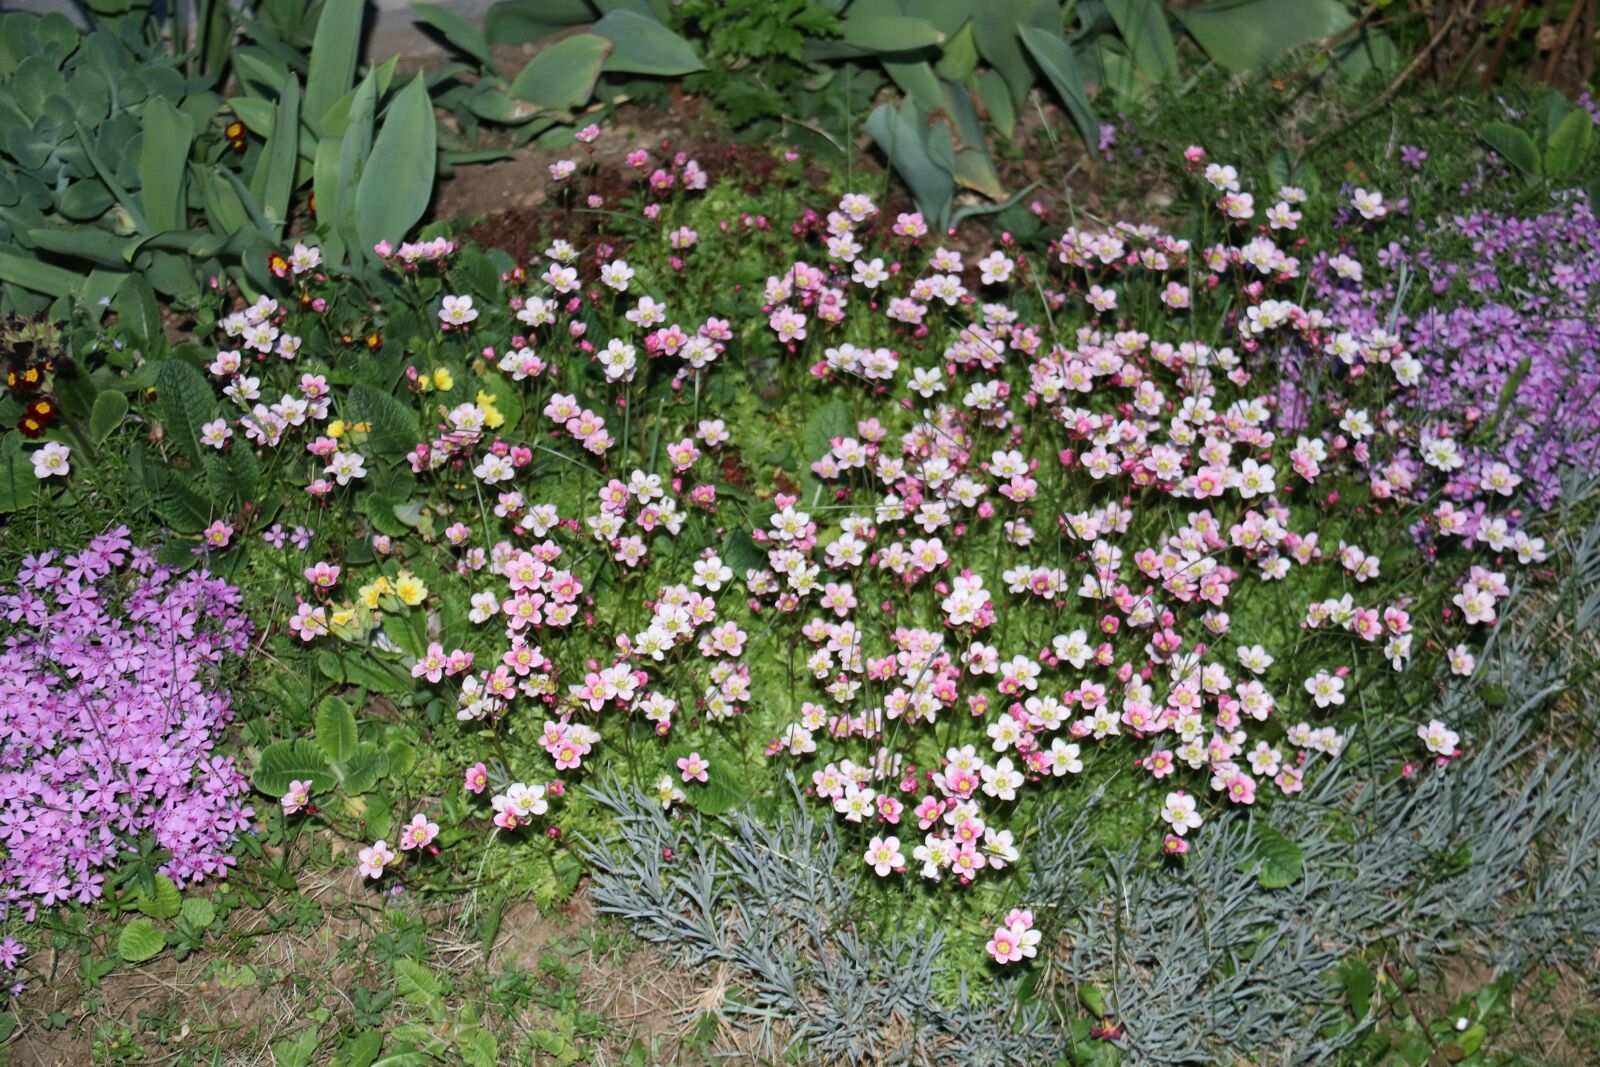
<box><xmin>0</xmin><ymin>530</ymin><xmax>254</xmax><ymax>917</ymax></box>
